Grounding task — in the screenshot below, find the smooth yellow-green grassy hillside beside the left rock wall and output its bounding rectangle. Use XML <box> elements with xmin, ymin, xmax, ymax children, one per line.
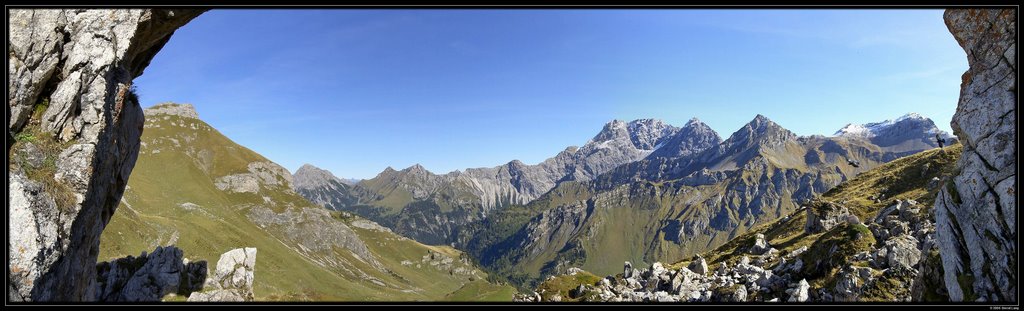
<box><xmin>99</xmin><ymin>109</ymin><xmax>516</xmax><ymax>301</ymax></box>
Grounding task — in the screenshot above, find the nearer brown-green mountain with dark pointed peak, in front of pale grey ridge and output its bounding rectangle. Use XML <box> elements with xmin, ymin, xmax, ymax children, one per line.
<box><xmin>467</xmin><ymin>115</ymin><xmax>950</xmax><ymax>281</ymax></box>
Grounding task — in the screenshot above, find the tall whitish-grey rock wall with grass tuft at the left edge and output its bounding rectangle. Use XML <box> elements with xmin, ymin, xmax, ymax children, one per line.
<box><xmin>7</xmin><ymin>9</ymin><xmax>202</xmax><ymax>301</ymax></box>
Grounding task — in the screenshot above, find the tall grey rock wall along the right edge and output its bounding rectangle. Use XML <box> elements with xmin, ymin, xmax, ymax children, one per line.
<box><xmin>935</xmin><ymin>9</ymin><xmax>1018</xmax><ymax>302</ymax></box>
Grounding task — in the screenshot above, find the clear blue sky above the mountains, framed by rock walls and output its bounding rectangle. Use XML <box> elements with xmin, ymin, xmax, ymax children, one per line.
<box><xmin>135</xmin><ymin>9</ymin><xmax>967</xmax><ymax>178</ymax></box>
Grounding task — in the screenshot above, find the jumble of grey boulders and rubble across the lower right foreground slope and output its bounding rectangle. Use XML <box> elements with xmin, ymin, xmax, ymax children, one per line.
<box><xmin>514</xmin><ymin>199</ymin><xmax>935</xmax><ymax>303</ymax></box>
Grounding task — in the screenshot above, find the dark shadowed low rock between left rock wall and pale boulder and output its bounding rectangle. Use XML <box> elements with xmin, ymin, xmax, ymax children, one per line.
<box><xmin>95</xmin><ymin>247</ymin><xmax>207</xmax><ymax>302</ymax></box>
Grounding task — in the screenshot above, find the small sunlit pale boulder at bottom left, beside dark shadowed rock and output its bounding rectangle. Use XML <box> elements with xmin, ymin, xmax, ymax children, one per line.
<box><xmin>188</xmin><ymin>248</ymin><xmax>256</xmax><ymax>302</ymax></box>
